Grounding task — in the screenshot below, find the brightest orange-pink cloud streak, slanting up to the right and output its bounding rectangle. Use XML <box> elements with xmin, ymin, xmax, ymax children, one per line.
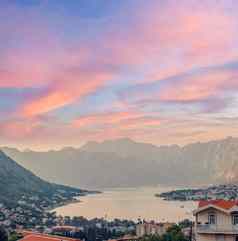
<box><xmin>20</xmin><ymin>70</ymin><xmax>113</xmax><ymax>117</ymax></box>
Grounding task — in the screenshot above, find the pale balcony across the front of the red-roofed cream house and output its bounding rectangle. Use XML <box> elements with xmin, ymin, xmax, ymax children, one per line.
<box><xmin>196</xmin><ymin>224</ymin><xmax>238</xmax><ymax>234</ymax></box>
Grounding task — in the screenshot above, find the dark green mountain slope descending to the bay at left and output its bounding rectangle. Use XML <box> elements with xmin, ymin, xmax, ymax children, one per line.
<box><xmin>0</xmin><ymin>151</ymin><xmax>83</xmax><ymax>206</ymax></box>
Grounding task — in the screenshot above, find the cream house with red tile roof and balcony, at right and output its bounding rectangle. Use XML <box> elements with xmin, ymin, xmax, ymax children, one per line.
<box><xmin>194</xmin><ymin>200</ymin><xmax>238</xmax><ymax>241</ymax></box>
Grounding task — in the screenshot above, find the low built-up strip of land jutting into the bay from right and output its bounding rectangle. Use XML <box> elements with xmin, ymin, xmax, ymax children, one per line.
<box><xmin>155</xmin><ymin>184</ymin><xmax>238</xmax><ymax>201</ymax></box>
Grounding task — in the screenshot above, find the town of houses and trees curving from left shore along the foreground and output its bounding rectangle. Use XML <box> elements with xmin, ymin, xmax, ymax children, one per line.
<box><xmin>0</xmin><ymin>183</ymin><xmax>191</xmax><ymax>241</ymax></box>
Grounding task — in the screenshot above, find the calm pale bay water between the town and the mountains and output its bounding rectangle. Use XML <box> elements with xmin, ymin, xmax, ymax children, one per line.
<box><xmin>54</xmin><ymin>187</ymin><xmax>197</xmax><ymax>222</ymax></box>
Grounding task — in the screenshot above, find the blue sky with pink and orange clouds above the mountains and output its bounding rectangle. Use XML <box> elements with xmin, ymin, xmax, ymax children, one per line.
<box><xmin>0</xmin><ymin>0</ymin><xmax>238</xmax><ymax>150</ymax></box>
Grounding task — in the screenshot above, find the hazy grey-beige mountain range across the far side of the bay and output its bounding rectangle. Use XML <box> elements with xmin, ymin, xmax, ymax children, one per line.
<box><xmin>2</xmin><ymin>137</ymin><xmax>238</xmax><ymax>188</ymax></box>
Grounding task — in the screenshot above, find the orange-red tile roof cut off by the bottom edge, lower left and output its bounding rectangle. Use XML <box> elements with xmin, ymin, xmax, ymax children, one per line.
<box><xmin>21</xmin><ymin>232</ymin><xmax>80</xmax><ymax>241</ymax></box>
